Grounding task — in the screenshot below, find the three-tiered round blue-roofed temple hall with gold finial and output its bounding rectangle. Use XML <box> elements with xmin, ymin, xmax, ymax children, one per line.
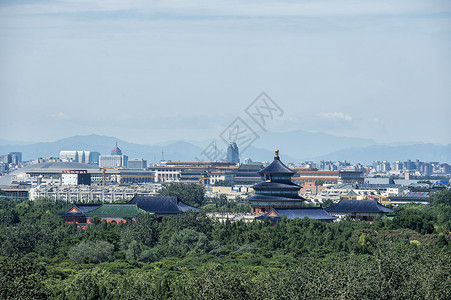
<box><xmin>248</xmin><ymin>150</ymin><xmax>305</xmax><ymax>213</ymax></box>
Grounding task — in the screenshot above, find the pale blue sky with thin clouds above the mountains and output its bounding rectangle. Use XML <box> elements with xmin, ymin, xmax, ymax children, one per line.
<box><xmin>0</xmin><ymin>0</ymin><xmax>451</xmax><ymax>144</ymax></box>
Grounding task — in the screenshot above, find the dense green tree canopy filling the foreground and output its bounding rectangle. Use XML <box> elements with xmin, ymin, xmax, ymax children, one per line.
<box><xmin>0</xmin><ymin>190</ymin><xmax>451</xmax><ymax>299</ymax></box>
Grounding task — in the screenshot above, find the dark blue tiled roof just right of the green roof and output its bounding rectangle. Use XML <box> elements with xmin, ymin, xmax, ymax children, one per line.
<box><xmin>128</xmin><ymin>196</ymin><xmax>199</xmax><ymax>214</ymax></box>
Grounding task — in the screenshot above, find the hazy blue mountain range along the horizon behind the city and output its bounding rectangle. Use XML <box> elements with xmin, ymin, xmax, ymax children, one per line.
<box><xmin>0</xmin><ymin>130</ymin><xmax>451</xmax><ymax>164</ymax></box>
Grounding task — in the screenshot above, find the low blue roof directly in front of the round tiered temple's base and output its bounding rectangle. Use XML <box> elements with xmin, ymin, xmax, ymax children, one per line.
<box><xmin>256</xmin><ymin>207</ymin><xmax>337</xmax><ymax>221</ymax></box>
